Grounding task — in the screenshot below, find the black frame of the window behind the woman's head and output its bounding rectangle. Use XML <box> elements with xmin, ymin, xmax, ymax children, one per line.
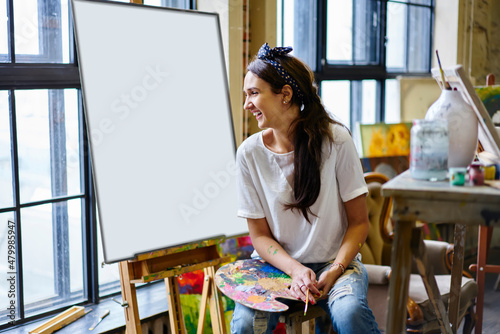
<box><xmin>278</xmin><ymin>0</ymin><xmax>435</xmax><ymax>125</ymax></box>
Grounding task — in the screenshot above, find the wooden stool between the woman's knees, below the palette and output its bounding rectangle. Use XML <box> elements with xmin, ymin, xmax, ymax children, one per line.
<box><xmin>279</xmin><ymin>303</ymin><xmax>326</xmax><ymax>334</ymax></box>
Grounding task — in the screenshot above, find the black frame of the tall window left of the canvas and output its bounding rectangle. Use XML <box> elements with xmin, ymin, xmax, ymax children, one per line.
<box><xmin>0</xmin><ymin>0</ymin><xmax>196</xmax><ymax>331</ymax></box>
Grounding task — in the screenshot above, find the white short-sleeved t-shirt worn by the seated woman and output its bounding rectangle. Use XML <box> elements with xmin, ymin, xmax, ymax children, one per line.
<box><xmin>236</xmin><ymin>124</ymin><xmax>368</xmax><ymax>263</ymax></box>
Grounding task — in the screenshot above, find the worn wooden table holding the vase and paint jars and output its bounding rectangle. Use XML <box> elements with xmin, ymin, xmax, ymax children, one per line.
<box><xmin>382</xmin><ymin>171</ymin><xmax>500</xmax><ymax>334</ymax></box>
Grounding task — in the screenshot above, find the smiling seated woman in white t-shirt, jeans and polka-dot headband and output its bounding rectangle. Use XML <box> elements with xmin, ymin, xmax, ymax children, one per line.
<box><xmin>231</xmin><ymin>43</ymin><xmax>379</xmax><ymax>334</ymax></box>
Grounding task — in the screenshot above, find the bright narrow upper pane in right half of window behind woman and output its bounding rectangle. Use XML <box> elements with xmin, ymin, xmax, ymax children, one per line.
<box><xmin>386</xmin><ymin>2</ymin><xmax>407</xmax><ymax>72</ymax></box>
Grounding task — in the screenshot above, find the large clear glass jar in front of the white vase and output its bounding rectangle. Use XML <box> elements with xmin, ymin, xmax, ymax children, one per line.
<box><xmin>410</xmin><ymin>119</ymin><xmax>449</xmax><ymax>180</ymax></box>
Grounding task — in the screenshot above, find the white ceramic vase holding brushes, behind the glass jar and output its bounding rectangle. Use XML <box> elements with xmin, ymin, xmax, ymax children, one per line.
<box><xmin>425</xmin><ymin>89</ymin><xmax>478</xmax><ymax>168</ymax></box>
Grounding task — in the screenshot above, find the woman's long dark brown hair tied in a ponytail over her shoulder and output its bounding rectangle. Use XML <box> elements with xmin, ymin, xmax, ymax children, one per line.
<box><xmin>247</xmin><ymin>54</ymin><xmax>338</xmax><ymax>222</ymax></box>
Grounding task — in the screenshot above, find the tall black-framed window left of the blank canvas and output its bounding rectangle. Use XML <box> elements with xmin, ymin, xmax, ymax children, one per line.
<box><xmin>0</xmin><ymin>0</ymin><xmax>192</xmax><ymax>330</ymax></box>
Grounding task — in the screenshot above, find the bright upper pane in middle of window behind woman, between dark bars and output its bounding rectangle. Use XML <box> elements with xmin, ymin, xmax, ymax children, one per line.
<box><xmin>326</xmin><ymin>0</ymin><xmax>353</xmax><ymax>63</ymax></box>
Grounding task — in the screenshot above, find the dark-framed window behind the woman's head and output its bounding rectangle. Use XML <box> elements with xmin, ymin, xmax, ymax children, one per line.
<box><xmin>278</xmin><ymin>0</ymin><xmax>434</xmax><ymax>133</ymax></box>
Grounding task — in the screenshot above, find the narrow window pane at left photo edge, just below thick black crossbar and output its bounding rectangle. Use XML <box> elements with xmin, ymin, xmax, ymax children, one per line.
<box><xmin>0</xmin><ymin>90</ymin><xmax>14</xmax><ymax>208</ymax></box>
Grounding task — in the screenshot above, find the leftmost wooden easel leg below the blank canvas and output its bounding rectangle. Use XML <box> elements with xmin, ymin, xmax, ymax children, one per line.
<box><xmin>119</xmin><ymin>261</ymin><xmax>142</xmax><ymax>334</ymax></box>
